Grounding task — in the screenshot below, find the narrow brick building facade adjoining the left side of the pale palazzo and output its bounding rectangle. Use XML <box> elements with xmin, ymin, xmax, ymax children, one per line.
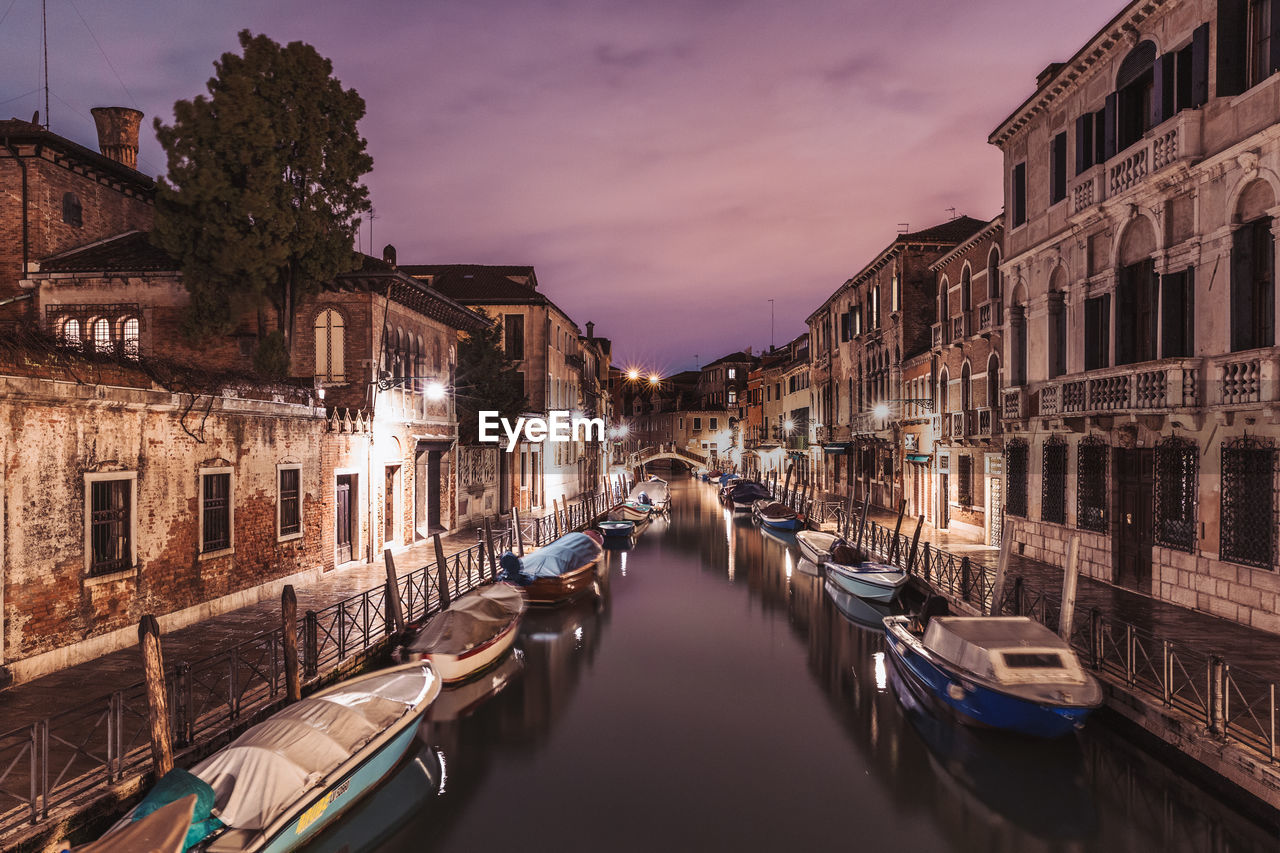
<box><xmin>931</xmin><ymin>216</ymin><xmax>1004</xmax><ymax>544</ymax></box>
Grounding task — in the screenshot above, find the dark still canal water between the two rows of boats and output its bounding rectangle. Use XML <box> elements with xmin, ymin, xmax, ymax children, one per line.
<box><xmin>308</xmin><ymin>478</ymin><xmax>1280</xmax><ymax>853</ymax></box>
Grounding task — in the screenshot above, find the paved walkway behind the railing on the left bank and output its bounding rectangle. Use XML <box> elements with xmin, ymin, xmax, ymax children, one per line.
<box><xmin>0</xmin><ymin>529</ymin><xmax>486</xmax><ymax>731</ymax></box>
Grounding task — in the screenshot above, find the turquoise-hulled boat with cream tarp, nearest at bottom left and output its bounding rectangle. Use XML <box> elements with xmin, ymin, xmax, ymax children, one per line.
<box><xmin>102</xmin><ymin>661</ymin><xmax>440</xmax><ymax>853</ymax></box>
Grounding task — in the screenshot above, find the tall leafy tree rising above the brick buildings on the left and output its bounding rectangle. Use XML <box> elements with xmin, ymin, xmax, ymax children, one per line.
<box><xmin>152</xmin><ymin>29</ymin><xmax>372</xmax><ymax>364</ymax></box>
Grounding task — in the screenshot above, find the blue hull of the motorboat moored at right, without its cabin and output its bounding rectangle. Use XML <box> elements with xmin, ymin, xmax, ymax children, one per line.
<box><xmin>884</xmin><ymin>619</ymin><xmax>1093</xmax><ymax>738</ymax></box>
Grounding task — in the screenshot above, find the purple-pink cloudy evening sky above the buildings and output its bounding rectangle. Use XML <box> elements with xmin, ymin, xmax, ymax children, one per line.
<box><xmin>0</xmin><ymin>0</ymin><xmax>1123</xmax><ymax>373</ymax></box>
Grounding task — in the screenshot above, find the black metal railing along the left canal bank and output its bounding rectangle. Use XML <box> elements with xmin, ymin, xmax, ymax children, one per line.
<box><xmin>0</xmin><ymin>485</ymin><xmax>625</xmax><ymax>835</ymax></box>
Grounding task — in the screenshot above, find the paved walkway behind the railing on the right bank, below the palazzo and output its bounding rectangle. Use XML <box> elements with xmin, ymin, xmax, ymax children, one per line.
<box><xmin>849</xmin><ymin>507</ymin><xmax>1280</xmax><ymax>683</ymax></box>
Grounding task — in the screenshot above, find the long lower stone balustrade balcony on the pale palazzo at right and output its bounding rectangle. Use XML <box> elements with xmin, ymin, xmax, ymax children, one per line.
<box><xmin>1039</xmin><ymin>359</ymin><xmax>1203</xmax><ymax>418</ymax></box>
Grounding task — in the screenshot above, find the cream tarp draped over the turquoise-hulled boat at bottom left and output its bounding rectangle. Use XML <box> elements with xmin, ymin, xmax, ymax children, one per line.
<box><xmin>192</xmin><ymin>666</ymin><xmax>436</xmax><ymax>830</ymax></box>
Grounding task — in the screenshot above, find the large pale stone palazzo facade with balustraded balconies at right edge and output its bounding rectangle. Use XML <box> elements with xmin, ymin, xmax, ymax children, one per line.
<box><xmin>989</xmin><ymin>0</ymin><xmax>1280</xmax><ymax>631</ymax></box>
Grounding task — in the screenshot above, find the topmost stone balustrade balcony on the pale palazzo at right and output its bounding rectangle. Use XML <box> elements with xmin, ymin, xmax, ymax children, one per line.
<box><xmin>1070</xmin><ymin>110</ymin><xmax>1202</xmax><ymax>215</ymax></box>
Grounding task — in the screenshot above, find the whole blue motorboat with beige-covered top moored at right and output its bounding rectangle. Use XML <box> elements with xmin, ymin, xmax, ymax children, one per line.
<box><xmin>884</xmin><ymin>616</ymin><xmax>1102</xmax><ymax>738</ymax></box>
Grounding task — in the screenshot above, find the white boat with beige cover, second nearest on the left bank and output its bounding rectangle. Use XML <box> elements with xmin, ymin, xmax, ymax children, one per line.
<box><xmin>407</xmin><ymin>583</ymin><xmax>527</xmax><ymax>683</ymax></box>
